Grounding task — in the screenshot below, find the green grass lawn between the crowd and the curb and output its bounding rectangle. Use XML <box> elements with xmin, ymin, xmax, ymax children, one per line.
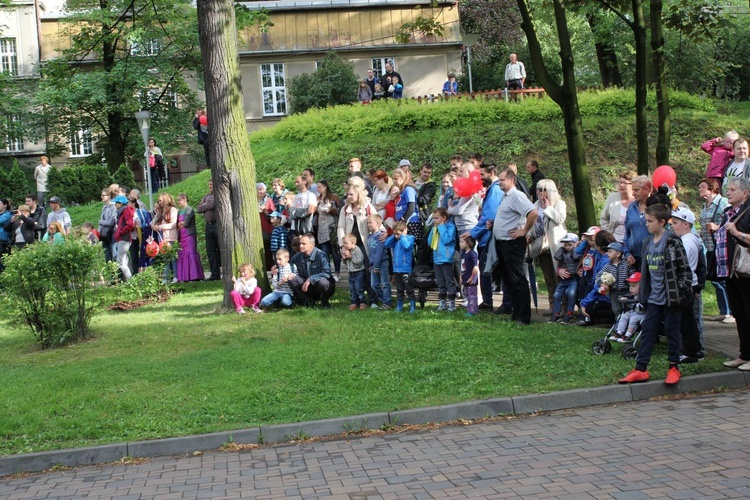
<box><xmin>0</xmin><ymin>283</ymin><xmax>723</xmax><ymax>455</ymax></box>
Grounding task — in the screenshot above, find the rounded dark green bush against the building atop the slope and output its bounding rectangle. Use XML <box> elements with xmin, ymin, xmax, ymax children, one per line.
<box><xmin>289</xmin><ymin>52</ymin><xmax>358</xmax><ymax>114</ymax></box>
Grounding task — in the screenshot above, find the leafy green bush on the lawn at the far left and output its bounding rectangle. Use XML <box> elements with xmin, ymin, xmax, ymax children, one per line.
<box><xmin>0</xmin><ymin>239</ymin><xmax>106</xmax><ymax>349</ymax></box>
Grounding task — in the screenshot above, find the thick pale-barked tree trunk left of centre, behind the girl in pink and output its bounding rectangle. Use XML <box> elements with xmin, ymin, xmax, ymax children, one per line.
<box><xmin>198</xmin><ymin>0</ymin><xmax>268</xmax><ymax>308</ymax></box>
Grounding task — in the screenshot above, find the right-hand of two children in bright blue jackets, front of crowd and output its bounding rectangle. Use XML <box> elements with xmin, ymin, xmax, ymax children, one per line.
<box><xmin>427</xmin><ymin>208</ymin><xmax>456</xmax><ymax>312</ymax></box>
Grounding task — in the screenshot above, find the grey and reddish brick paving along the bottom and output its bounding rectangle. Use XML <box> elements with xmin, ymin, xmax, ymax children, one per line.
<box><xmin>0</xmin><ymin>390</ymin><xmax>750</xmax><ymax>500</ymax></box>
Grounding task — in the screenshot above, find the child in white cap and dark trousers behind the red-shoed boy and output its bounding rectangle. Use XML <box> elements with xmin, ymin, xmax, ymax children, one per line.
<box><xmin>672</xmin><ymin>207</ymin><xmax>706</xmax><ymax>363</ymax></box>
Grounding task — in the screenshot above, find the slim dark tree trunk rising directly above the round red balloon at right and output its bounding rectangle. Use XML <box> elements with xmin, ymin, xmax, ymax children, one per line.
<box><xmin>650</xmin><ymin>0</ymin><xmax>672</xmax><ymax>165</ymax></box>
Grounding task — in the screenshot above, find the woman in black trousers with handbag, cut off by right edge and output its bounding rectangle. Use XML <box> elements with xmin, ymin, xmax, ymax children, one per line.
<box><xmin>716</xmin><ymin>177</ymin><xmax>750</xmax><ymax>371</ymax></box>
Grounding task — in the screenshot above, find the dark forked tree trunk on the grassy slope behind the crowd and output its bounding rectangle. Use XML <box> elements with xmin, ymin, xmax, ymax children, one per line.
<box><xmin>517</xmin><ymin>0</ymin><xmax>596</xmax><ymax>230</ymax></box>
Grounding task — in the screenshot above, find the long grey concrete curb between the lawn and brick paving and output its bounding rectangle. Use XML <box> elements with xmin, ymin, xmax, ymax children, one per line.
<box><xmin>0</xmin><ymin>371</ymin><xmax>750</xmax><ymax>476</ymax></box>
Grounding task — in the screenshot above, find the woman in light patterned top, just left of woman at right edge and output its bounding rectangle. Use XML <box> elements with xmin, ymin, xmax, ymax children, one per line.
<box><xmin>698</xmin><ymin>178</ymin><xmax>734</xmax><ymax>323</ymax></box>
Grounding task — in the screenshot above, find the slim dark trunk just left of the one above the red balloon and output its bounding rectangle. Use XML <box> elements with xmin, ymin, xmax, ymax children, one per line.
<box><xmin>632</xmin><ymin>0</ymin><xmax>649</xmax><ymax>175</ymax></box>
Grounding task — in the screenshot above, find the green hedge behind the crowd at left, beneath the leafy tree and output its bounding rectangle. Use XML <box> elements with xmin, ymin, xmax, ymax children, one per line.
<box><xmin>47</xmin><ymin>164</ymin><xmax>112</xmax><ymax>205</ymax></box>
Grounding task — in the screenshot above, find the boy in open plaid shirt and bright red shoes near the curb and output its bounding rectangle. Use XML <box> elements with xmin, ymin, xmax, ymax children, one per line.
<box><xmin>619</xmin><ymin>203</ymin><xmax>692</xmax><ymax>385</ymax></box>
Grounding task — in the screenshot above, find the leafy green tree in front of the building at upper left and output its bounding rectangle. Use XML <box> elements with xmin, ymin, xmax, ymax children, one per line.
<box><xmin>35</xmin><ymin>0</ymin><xmax>200</xmax><ymax>170</ymax></box>
